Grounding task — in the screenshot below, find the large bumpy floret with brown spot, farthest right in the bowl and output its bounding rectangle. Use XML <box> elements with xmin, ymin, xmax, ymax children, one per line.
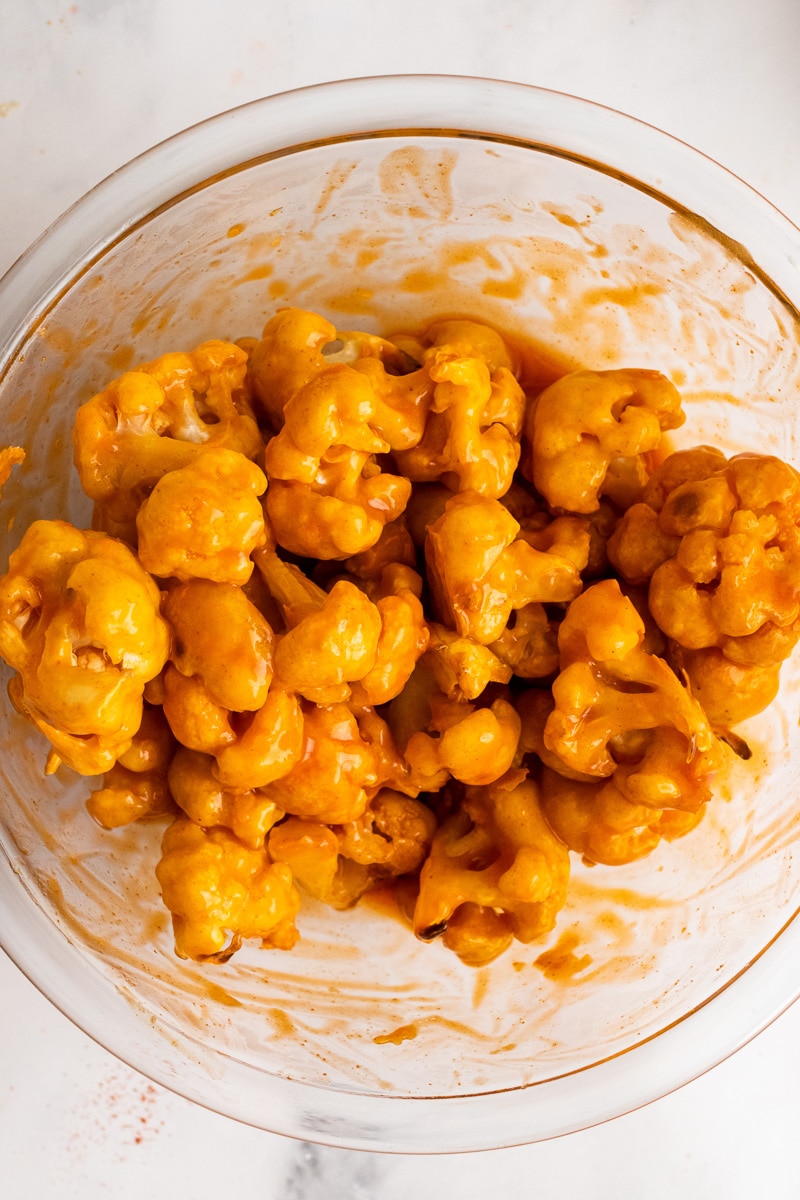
<box><xmin>609</xmin><ymin>446</ymin><xmax>800</xmax><ymax>728</ymax></box>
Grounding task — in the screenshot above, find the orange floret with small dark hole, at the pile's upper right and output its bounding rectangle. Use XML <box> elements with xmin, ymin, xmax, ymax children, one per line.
<box><xmin>523</xmin><ymin>370</ymin><xmax>684</xmax><ymax>512</ymax></box>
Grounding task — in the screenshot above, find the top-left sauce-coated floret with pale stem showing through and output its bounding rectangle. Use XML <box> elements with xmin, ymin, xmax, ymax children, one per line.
<box><xmin>73</xmin><ymin>341</ymin><xmax>264</xmax><ymax>541</ymax></box>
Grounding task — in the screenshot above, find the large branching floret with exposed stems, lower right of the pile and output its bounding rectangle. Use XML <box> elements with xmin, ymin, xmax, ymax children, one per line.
<box><xmin>542</xmin><ymin>580</ymin><xmax>722</xmax><ymax>863</ymax></box>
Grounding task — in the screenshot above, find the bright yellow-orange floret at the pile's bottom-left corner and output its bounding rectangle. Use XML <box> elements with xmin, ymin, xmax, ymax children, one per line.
<box><xmin>156</xmin><ymin>817</ymin><xmax>300</xmax><ymax>962</ymax></box>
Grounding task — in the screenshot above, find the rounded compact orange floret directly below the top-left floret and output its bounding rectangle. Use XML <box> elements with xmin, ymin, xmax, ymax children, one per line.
<box><xmin>136</xmin><ymin>448</ymin><xmax>267</xmax><ymax>583</ymax></box>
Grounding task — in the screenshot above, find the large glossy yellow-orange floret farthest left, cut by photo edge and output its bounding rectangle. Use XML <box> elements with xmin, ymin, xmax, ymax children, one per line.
<box><xmin>0</xmin><ymin>521</ymin><xmax>169</xmax><ymax>775</ymax></box>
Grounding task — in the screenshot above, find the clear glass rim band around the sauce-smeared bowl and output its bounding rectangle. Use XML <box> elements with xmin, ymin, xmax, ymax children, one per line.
<box><xmin>0</xmin><ymin>76</ymin><xmax>800</xmax><ymax>1153</ymax></box>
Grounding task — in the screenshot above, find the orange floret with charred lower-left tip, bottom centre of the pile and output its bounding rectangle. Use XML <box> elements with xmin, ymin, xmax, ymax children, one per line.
<box><xmin>414</xmin><ymin>778</ymin><xmax>570</xmax><ymax>962</ymax></box>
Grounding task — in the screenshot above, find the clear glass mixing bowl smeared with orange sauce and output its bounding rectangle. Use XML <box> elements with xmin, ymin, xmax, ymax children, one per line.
<box><xmin>0</xmin><ymin>77</ymin><xmax>800</xmax><ymax>1152</ymax></box>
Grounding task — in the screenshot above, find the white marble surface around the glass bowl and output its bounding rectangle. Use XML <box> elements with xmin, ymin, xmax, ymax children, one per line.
<box><xmin>0</xmin><ymin>0</ymin><xmax>800</xmax><ymax>1200</ymax></box>
